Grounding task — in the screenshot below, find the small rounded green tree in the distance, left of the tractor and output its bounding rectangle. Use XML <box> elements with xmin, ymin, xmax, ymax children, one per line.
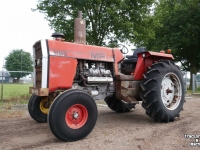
<box><xmin>5</xmin><ymin>49</ymin><xmax>33</xmax><ymax>82</ymax></box>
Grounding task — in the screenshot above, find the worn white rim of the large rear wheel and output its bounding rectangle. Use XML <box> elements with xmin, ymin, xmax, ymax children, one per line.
<box><xmin>161</xmin><ymin>73</ymin><xmax>182</xmax><ymax>110</ymax></box>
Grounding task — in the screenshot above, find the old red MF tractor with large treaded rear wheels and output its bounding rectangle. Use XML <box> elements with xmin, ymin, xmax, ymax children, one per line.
<box><xmin>28</xmin><ymin>34</ymin><xmax>185</xmax><ymax>141</ymax></box>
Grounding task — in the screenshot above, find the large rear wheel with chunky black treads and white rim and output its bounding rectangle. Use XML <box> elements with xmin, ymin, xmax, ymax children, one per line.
<box><xmin>140</xmin><ymin>60</ymin><xmax>185</xmax><ymax>122</ymax></box>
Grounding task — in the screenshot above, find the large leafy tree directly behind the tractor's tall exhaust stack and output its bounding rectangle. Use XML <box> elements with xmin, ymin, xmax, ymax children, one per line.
<box><xmin>33</xmin><ymin>0</ymin><xmax>155</xmax><ymax>45</ymax></box>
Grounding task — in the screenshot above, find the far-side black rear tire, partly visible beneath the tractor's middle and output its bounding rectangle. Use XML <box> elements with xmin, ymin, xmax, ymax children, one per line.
<box><xmin>104</xmin><ymin>94</ymin><xmax>135</xmax><ymax>113</ymax></box>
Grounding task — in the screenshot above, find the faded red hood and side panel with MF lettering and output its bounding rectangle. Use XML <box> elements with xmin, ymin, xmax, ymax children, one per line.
<box><xmin>47</xmin><ymin>40</ymin><xmax>124</xmax><ymax>92</ymax></box>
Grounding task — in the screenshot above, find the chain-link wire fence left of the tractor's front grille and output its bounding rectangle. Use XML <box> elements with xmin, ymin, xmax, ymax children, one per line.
<box><xmin>0</xmin><ymin>71</ymin><xmax>33</xmax><ymax>100</ymax></box>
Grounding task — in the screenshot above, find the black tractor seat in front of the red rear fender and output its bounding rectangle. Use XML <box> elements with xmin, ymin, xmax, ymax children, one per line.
<box><xmin>123</xmin><ymin>47</ymin><xmax>146</xmax><ymax>64</ymax></box>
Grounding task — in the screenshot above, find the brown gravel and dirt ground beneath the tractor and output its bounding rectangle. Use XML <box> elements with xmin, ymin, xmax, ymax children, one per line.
<box><xmin>0</xmin><ymin>97</ymin><xmax>200</xmax><ymax>150</ymax></box>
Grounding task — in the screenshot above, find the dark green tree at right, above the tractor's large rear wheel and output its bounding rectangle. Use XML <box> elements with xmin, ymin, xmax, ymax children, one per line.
<box><xmin>134</xmin><ymin>0</ymin><xmax>200</xmax><ymax>87</ymax></box>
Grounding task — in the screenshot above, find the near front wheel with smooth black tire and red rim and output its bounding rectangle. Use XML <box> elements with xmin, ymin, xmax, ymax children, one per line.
<box><xmin>48</xmin><ymin>90</ymin><xmax>97</xmax><ymax>141</ymax></box>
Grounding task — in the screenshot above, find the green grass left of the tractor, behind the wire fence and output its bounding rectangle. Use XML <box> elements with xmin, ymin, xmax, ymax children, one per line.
<box><xmin>0</xmin><ymin>84</ymin><xmax>32</xmax><ymax>108</ymax></box>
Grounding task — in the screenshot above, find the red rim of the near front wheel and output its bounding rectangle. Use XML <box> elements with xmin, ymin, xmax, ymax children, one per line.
<box><xmin>65</xmin><ymin>104</ymin><xmax>88</xmax><ymax>129</ymax></box>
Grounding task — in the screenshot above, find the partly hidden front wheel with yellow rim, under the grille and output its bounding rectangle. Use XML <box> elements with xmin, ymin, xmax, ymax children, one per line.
<box><xmin>28</xmin><ymin>95</ymin><xmax>51</xmax><ymax>123</ymax></box>
